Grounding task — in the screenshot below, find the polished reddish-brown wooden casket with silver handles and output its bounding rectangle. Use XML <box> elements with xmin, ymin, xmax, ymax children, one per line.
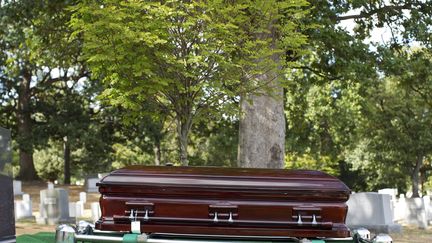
<box><xmin>96</xmin><ymin>166</ymin><xmax>350</xmax><ymax>238</ymax></box>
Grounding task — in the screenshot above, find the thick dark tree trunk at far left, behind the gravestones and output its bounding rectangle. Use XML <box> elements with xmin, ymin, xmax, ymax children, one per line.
<box><xmin>16</xmin><ymin>71</ymin><xmax>39</xmax><ymax>181</ymax></box>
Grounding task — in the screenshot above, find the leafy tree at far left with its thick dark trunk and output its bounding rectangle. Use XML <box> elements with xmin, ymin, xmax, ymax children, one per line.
<box><xmin>0</xmin><ymin>0</ymin><xmax>86</xmax><ymax>180</ymax></box>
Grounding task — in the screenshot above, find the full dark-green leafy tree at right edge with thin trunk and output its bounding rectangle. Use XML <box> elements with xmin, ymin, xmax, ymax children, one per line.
<box><xmin>356</xmin><ymin>49</ymin><xmax>432</xmax><ymax>196</ymax></box>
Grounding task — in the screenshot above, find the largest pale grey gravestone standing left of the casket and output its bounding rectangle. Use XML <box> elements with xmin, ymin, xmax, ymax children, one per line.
<box><xmin>36</xmin><ymin>186</ymin><xmax>75</xmax><ymax>225</ymax></box>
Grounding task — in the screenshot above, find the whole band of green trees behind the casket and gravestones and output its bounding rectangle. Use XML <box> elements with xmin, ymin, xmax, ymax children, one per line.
<box><xmin>0</xmin><ymin>0</ymin><xmax>432</xmax><ymax>196</ymax></box>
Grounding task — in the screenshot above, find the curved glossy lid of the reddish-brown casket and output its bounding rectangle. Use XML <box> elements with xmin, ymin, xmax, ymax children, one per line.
<box><xmin>98</xmin><ymin>166</ymin><xmax>350</xmax><ymax>196</ymax></box>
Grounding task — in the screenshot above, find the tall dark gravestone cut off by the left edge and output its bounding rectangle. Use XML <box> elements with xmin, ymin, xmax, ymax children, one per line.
<box><xmin>0</xmin><ymin>127</ymin><xmax>15</xmax><ymax>242</ymax></box>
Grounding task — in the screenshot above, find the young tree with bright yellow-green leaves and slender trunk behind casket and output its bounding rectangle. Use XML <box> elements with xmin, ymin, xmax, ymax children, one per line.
<box><xmin>72</xmin><ymin>0</ymin><xmax>306</xmax><ymax>165</ymax></box>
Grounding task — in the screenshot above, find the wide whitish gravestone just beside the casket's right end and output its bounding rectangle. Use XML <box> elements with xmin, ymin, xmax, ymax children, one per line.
<box><xmin>346</xmin><ymin>192</ymin><xmax>402</xmax><ymax>233</ymax></box>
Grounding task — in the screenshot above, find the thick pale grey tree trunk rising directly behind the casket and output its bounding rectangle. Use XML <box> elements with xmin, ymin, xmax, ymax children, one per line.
<box><xmin>237</xmin><ymin>16</ymin><xmax>285</xmax><ymax>168</ymax></box>
